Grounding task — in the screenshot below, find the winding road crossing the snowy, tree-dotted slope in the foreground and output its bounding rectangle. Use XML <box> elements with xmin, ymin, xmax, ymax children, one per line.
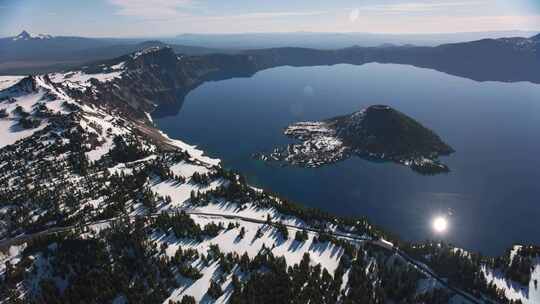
<box><xmin>0</xmin><ymin>208</ymin><xmax>490</xmax><ymax>304</ymax></box>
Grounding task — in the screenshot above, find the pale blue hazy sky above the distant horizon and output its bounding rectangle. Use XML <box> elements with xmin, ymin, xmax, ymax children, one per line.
<box><xmin>0</xmin><ymin>0</ymin><xmax>540</xmax><ymax>37</ymax></box>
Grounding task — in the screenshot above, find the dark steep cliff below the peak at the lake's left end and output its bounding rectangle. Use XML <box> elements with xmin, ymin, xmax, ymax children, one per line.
<box><xmin>73</xmin><ymin>47</ymin><xmax>259</xmax><ymax>119</ymax></box>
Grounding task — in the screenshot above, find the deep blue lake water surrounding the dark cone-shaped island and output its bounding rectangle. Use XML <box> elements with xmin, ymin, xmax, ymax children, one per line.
<box><xmin>156</xmin><ymin>64</ymin><xmax>540</xmax><ymax>254</ymax></box>
